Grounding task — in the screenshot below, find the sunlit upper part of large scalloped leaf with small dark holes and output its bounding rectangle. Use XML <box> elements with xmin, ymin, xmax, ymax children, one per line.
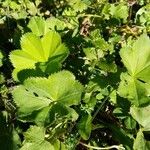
<box><xmin>13</xmin><ymin>71</ymin><xmax>83</xmax><ymax>120</ymax></box>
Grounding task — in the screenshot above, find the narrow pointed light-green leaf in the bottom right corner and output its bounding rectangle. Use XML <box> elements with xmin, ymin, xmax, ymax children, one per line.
<box><xmin>133</xmin><ymin>130</ymin><xmax>148</xmax><ymax>150</ymax></box>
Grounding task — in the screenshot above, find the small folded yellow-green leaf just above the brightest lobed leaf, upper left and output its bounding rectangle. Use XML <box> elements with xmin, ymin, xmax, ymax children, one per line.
<box><xmin>28</xmin><ymin>16</ymin><xmax>49</xmax><ymax>36</ymax></box>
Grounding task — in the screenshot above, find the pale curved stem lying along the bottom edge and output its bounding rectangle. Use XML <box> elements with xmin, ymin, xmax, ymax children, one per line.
<box><xmin>80</xmin><ymin>142</ymin><xmax>125</xmax><ymax>150</ymax></box>
